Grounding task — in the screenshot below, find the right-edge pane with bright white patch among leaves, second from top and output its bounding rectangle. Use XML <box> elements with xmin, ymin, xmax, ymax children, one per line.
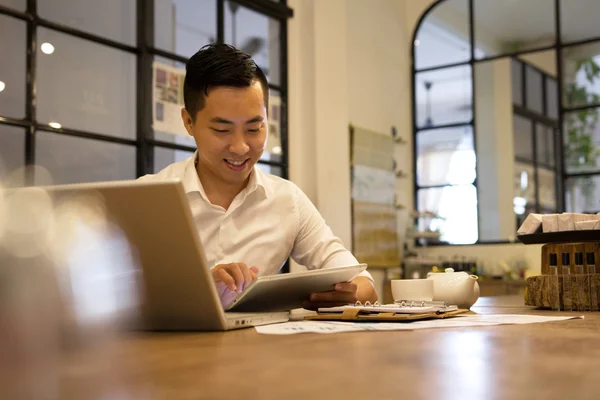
<box><xmin>563</xmin><ymin>43</ymin><xmax>600</xmax><ymax>107</ymax></box>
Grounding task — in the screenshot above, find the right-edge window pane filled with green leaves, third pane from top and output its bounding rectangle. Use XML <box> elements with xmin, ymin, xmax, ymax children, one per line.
<box><xmin>563</xmin><ymin>108</ymin><xmax>600</xmax><ymax>173</ymax></box>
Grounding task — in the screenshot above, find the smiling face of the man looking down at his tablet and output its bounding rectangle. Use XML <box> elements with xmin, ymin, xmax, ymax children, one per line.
<box><xmin>181</xmin><ymin>81</ymin><xmax>268</xmax><ymax>188</ymax></box>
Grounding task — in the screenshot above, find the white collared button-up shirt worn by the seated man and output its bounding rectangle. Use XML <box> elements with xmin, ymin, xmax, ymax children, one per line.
<box><xmin>139</xmin><ymin>152</ymin><xmax>372</xmax><ymax>279</ymax></box>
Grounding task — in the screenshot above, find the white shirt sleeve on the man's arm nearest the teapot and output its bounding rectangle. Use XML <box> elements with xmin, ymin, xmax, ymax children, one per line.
<box><xmin>291</xmin><ymin>185</ymin><xmax>373</xmax><ymax>280</ymax></box>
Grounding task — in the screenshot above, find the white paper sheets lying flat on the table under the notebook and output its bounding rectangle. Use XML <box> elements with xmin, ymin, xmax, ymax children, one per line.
<box><xmin>255</xmin><ymin>314</ymin><xmax>583</xmax><ymax>335</ymax></box>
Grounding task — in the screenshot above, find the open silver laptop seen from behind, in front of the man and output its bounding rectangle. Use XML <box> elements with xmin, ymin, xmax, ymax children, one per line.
<box><xmin>38</xmin><ymin>180</ymin><xmax>289</xmax><ymax>331</ymax></box>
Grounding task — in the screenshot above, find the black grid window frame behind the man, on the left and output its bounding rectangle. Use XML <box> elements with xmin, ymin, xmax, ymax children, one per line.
<box><xmin>0</xmin><ymin>0</ymin><xmax>293</xmax><ymax>186</ymax></box>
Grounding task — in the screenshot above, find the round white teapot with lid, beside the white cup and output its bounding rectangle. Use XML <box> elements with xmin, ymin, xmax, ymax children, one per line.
<box><xmin>427</xmin><ymin>268</ymin><xmax>479</xmax><ymax>308</ymax></box>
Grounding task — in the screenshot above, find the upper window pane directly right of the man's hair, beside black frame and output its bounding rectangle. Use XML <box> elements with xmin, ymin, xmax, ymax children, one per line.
<box><xmin>225</xmin><ymin>1</ymin><xmax>281</xmax><ymax>85</ymax></box>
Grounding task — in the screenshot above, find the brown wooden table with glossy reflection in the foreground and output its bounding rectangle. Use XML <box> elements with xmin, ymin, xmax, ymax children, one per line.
<box><xmin>52</xmin><ymin>296</ymin><xmax>600</xmax><ymax>400</ymax></box>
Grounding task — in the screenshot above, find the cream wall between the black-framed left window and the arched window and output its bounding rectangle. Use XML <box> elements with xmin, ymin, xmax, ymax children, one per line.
<box><xmin>288</xmin><ymin>0</ymin><xmax>432</xmax><ymax>293</ymax></box>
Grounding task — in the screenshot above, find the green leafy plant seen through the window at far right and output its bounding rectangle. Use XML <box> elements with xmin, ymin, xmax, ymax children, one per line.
<box><xmin>563</xmin><ymin>57</ymin><xmax>600</xmax><ymax>206</ymax></box>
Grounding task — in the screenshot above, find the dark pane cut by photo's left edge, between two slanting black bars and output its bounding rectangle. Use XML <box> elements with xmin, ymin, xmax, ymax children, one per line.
<box><xmin>0</xmin><ymin>15</ymin><xmax>27</xmax><ymax>118</ymax></box>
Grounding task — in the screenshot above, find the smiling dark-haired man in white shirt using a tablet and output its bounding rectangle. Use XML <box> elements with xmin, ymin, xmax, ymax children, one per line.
<box><xmin>140</xmin><ymin>44</ymin><xmax>377</xmax><ymax>309</ymax></box>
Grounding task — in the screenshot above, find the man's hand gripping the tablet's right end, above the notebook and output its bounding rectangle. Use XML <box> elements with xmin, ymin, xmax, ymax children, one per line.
<box><xmin>302</xmin><ymin>276</ymin><xmax>377</xmax><ymax>310</ymax></box>
